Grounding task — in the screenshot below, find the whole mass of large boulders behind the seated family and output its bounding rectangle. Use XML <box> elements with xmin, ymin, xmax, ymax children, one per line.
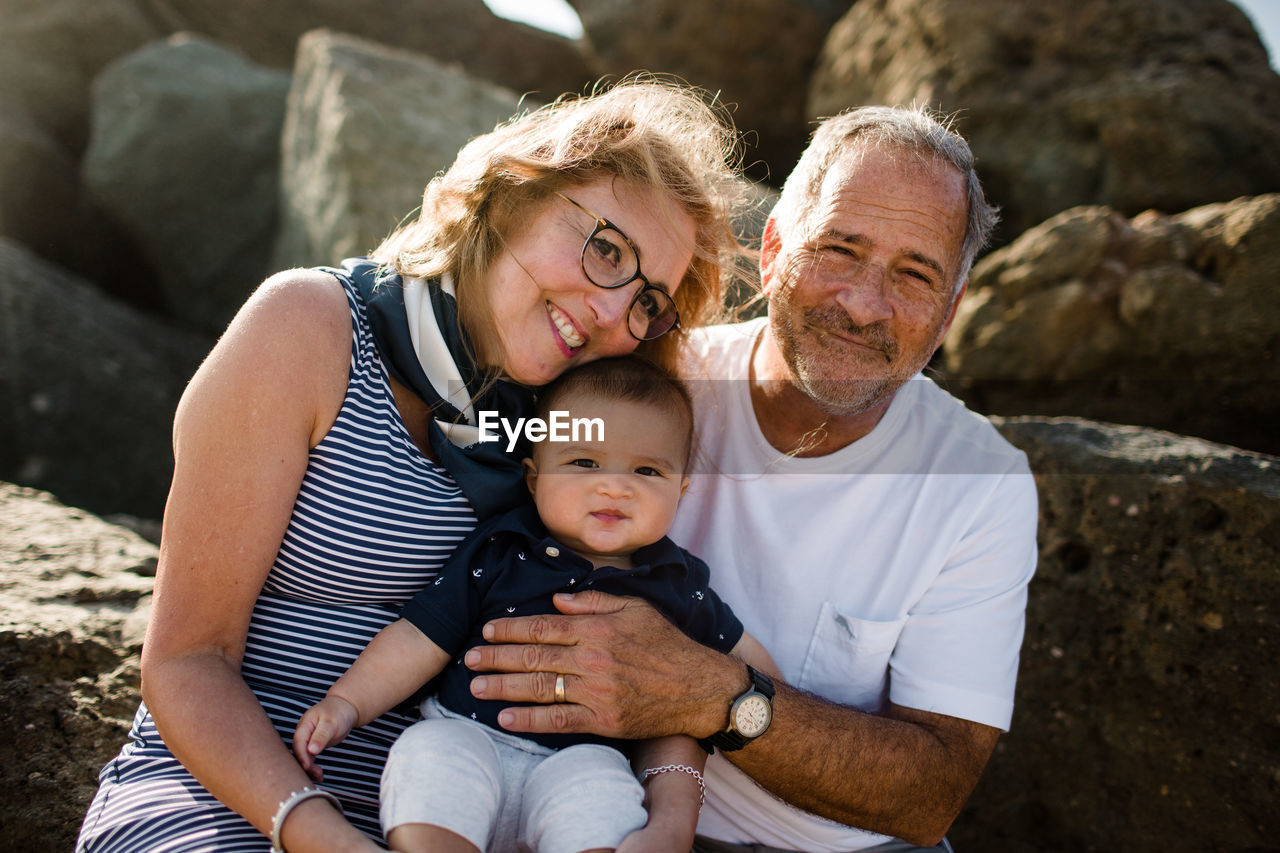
<box><xmin>0</xmin><ymin>0</ymin><xmax>1280</xmax><ymax>853</ymax></box>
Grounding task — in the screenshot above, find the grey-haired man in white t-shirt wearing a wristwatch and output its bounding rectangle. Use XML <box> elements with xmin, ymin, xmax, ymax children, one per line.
<box><xmin>468</xmin><ymin>108</ymin><xmax>1037</xmax><ymax>850</ymax></box>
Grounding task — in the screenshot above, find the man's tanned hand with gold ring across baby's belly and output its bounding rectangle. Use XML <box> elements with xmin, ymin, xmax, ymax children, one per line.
<box><xmin>466</xmin><ymin>592</ymin><xmax>748</xmax><ymax>739</ymax></box>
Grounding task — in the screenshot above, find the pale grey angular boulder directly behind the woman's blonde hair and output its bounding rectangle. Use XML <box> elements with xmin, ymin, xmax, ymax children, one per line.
<box><xmin>275</xmin><ymin>31</ymin><xmax>520</xmax><ymax>268</ymax></box>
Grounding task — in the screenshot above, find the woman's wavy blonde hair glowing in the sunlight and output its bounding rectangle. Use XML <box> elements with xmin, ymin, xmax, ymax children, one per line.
<box><xmin>372</xmin><ymin>76</ymin><xmax>751</xmax><ymax>375</ymax></box>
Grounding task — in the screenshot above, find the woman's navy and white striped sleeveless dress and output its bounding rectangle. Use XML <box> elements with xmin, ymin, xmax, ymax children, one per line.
<box><xmin>76</xmin><ymin>272</ymin><xmax>476</xmax><ymax>853</ymax></box>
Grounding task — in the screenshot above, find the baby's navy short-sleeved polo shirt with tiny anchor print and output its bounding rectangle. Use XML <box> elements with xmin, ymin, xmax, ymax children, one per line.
<box><xmin>401</xmin><ymin>503</ymin><xmax>742</xmax><ymax>749</ymax></box>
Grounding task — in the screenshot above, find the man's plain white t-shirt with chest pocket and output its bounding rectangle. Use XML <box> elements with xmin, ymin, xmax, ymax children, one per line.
<box><xmin>671</xmin><ymin>319</ymin><xmax>1038</xmax><ymax>852</ymax></box>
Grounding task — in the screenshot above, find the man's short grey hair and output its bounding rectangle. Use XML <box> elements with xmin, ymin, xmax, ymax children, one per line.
<box><xmin>773</xmin><ymin>106</ymin><xmax>1000</xmax><ymax>288</ymax></box>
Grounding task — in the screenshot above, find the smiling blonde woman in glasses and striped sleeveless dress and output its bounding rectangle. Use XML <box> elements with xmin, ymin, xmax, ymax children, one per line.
<box><xmin>77</xmin><ymin>81</ymin><xmax>739</xmax><ymax>853</ymax></box>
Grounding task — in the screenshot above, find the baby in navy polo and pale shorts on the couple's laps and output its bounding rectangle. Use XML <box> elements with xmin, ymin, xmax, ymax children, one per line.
<box><xmin>293</xmin><ymin>357</ymin><xmax>777</xmax><ymax>853</ymax></box>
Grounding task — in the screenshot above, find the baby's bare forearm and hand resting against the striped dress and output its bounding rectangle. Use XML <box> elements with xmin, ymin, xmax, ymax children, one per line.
<box><xmin>293</xmin><ymin>619</ymin><xmax>449</xmax><ymax>781</ymax></box>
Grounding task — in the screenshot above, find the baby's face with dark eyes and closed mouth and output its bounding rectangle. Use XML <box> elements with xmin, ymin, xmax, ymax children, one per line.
<box><xmin>525</xmin><ymin>394</ymin><xmax>689</xmax><ymax>569</ymax></box>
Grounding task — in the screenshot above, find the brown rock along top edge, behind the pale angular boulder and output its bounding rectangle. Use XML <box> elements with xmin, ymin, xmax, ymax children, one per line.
<box><xmin>141</xmin><ymin>0</ymin><xmax>595</xmax><ymax>100</ymax></box>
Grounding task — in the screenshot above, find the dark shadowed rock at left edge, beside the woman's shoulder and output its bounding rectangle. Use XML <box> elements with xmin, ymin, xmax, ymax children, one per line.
<box><xmin>0</xmin><ymin>238</ymin><xmax>212</xmax><ymax>519</ymax></box>
